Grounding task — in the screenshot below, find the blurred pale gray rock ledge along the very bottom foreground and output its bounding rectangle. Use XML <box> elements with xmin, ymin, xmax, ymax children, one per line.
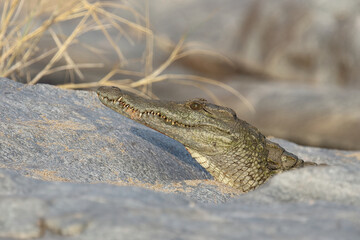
<box><xmin>0</xmin><ymin>167</ymin><xmax>360</xmax><ymax>239</ymax></box>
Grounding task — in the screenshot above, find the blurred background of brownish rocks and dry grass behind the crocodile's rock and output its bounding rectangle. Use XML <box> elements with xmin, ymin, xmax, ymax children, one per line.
<box><xmin>0</xmin><ymin>0</ymin><xmax>360</xmax><ymax>150</ymax></box>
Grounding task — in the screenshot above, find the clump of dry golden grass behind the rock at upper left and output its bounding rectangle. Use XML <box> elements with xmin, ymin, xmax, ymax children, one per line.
<box><xmin>0</xmin><ymin>0</ymin><xmax>254</xmax><ymax>111</ymax></box>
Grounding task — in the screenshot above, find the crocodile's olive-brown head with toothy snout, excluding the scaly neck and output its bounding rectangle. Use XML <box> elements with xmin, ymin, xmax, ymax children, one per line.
<box><xmin>97</xmin><ymin>87</ymin><xmax>239</xmax><ymax>155</ymax></box>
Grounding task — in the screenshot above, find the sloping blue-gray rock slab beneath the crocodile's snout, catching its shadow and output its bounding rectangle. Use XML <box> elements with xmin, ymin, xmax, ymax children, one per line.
<box><xmin>0</xmin><ymin>79</ymin><xmax>210</xmax><ymax>184</ymax></box>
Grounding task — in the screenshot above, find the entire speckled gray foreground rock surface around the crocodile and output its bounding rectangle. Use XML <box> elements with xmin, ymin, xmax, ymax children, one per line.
<box><xmin>0</xmin><ymin>79</ymin><xmax>360</xmax><ymax>239</ymax></box>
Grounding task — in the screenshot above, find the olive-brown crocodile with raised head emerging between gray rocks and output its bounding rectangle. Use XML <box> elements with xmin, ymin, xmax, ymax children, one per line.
<box><xmin>96</xmin><ymin>86</ymin><xmax>316</xmax><ymax>192</ymax></box>
